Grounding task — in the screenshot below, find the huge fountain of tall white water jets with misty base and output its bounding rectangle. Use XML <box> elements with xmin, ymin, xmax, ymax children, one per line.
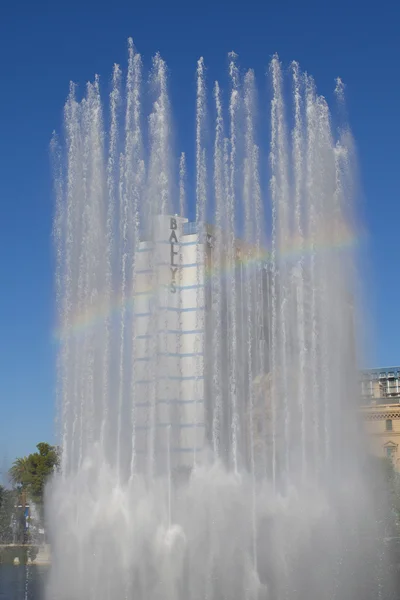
<box><xmin>47</xmin><ymin>40</ymin><xmax>394</xmax><ymax>600</ymax></box>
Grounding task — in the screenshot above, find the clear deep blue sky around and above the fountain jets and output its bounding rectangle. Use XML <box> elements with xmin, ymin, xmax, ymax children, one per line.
<box><xmin>0</xmin><ymin>0</ymin><xmax>400</xmax><ymax>464</ymax></box>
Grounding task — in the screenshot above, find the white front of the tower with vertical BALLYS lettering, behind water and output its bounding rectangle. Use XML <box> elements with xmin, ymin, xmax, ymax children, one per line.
<box><xmin>133</xmin><ymin>216</ymin><xmax>206</xmax><ymax>468</ymax></box>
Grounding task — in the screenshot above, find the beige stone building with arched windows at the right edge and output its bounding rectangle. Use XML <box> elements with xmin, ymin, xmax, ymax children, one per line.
<box><xmin>360</xmin><ymin>367</ymin><xmax>400</xmax><ymax>472</ymax></box>
